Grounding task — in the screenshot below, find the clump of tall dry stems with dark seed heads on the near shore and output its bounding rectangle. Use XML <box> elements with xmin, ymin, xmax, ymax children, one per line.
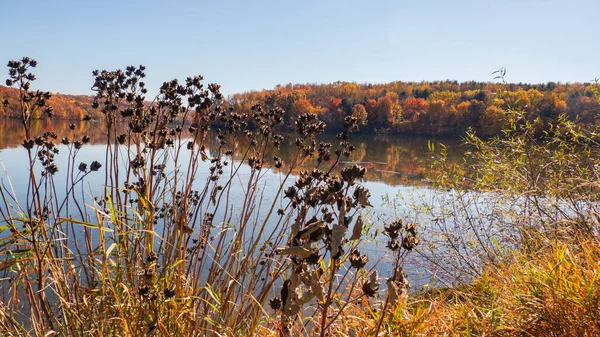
<box><xmin>0</xmin><ymin>61</ymin><xmax>418</xmax><ymax>336</ymax></box>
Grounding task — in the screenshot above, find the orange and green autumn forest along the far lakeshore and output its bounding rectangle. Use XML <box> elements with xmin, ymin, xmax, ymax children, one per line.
<box><xmin>0</xmin><ymin>80</ymin><xmax>600</xmax><ymax>137</ymax></box>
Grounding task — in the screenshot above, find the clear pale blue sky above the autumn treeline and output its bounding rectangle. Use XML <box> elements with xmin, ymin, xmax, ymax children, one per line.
<box><xmin>0</xmin><ymin>0</ymin><xmax>600</xmax><ymax>94</ymax></box>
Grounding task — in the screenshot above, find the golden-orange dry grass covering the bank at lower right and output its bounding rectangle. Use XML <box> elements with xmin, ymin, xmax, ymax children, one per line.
<box><xmin>322</xmin><ymin>236</ymin><xmax>600</xmax><ymax>337</ymax></box>
